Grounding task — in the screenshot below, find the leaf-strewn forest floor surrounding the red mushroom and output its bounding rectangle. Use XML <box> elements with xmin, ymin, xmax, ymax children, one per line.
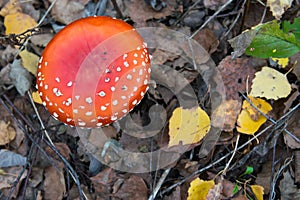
<box><xmin>0</xmin><ymin>0</ymin><xmax>300</xmax><ymax>200</ymax></box>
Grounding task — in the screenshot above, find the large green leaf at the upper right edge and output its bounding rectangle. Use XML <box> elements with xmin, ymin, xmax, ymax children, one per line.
<box><xmin>245</xmin><ymin>18</ymin><xmax>300</xmax><ymax>58</ymax></box>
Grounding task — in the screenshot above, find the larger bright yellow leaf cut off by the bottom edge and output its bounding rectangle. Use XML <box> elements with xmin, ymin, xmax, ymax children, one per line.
<box><xmin>187</xmin><ymin>178</ymin><xmax>215</xmax><ymax>200</ymax></box>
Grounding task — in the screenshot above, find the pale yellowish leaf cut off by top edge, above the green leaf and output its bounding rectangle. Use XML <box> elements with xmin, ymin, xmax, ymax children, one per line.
<box><xmin>267</xmin><ymin>0</ymin><xmax>293</xmax><ymax>20</ymax></box>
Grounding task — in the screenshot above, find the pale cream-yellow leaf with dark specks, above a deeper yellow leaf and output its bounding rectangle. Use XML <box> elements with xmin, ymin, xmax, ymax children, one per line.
<box><xmin>250</xmin><ymin>67</ymin><xmax>291</xmax><ymax>100</ymax></box>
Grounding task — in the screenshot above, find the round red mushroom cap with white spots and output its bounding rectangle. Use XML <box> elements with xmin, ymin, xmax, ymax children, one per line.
<box><xmin>37</xmin><ymin>16</ymin><xmax>151</xmax><ymax>127</ymax></box>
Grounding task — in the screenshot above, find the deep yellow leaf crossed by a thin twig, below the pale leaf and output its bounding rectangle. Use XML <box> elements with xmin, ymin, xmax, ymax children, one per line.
<box><xmin>237</xmin><ymin>96</ymin><xmax>272</xmax><ymax>135</ymax></box>
